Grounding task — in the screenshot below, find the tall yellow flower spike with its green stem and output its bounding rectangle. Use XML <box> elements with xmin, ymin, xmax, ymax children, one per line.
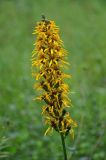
<box><xmin>32</xmin><ymin>16</ymin><xmax>77</xmax><ymax>160</ymax></box>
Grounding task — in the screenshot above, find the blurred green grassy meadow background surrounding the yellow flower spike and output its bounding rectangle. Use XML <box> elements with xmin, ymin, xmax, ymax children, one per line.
<box><xmin>0</xmin><ymin>0</ymin><xmax>106</xmax><ymax>160</ymax></box>
